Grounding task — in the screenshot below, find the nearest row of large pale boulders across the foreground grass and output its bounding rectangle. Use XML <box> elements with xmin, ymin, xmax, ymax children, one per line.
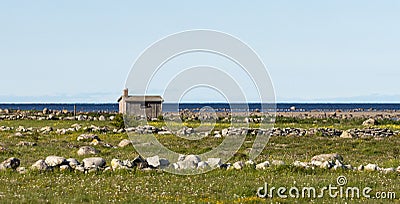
<box><xmin>0</xmin><ymin>153</ymin><xmax>400</xmax><ymax>173</ymax></box>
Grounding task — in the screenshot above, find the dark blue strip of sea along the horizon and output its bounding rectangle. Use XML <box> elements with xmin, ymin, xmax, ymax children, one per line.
<box><xmin>0</xmin><ymin>103</ymin><xmax>400</xmax><ymax>112</ymax></box>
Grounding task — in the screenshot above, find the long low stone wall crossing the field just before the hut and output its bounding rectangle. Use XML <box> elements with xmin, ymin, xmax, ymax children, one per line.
<box><xmin>0</xmin><ymin>121</ymin><xmax>400</xmax><ymax>140</ymax></box>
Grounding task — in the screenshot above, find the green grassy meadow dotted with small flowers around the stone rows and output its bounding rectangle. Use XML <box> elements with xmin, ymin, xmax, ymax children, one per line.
<box><xmin>0</xmin><ymin>118</ymin><xmax>400</xmax><ymax>203</ymax></box>
